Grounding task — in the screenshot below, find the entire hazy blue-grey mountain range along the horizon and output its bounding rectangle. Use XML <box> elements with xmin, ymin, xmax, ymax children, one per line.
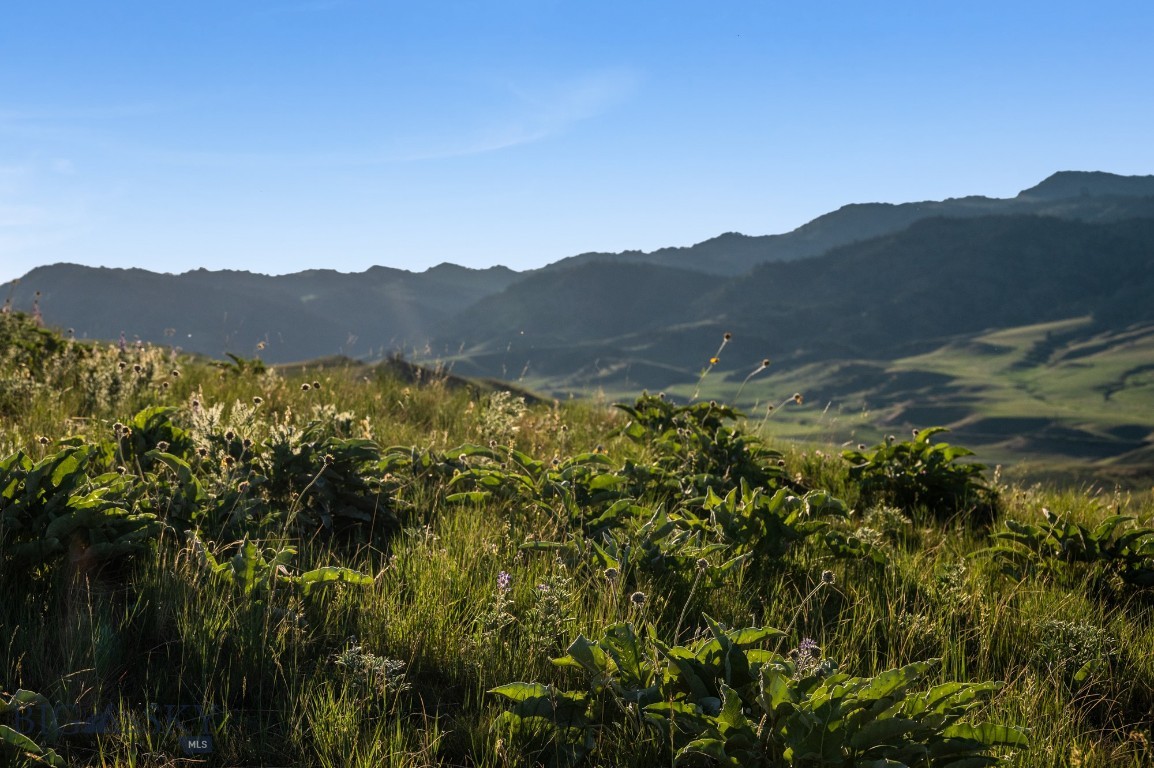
<box><xmin>6</xmin><ymin>172</ymin><xmax>1154</xmax><ymax>472</ymax></box>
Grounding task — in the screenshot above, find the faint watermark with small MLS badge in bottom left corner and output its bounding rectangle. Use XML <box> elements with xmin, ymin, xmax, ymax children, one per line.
<box><xmin>0</xmin><ymin>702</ymin><xmax>223</xmax><ymax>755</ymax></box>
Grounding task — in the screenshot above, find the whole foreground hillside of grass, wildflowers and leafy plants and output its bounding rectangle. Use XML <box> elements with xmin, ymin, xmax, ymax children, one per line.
<box><xmin>0</xmin><ymin>315</ymin><xmax>1154</xmax><ymax>768</ymax></box>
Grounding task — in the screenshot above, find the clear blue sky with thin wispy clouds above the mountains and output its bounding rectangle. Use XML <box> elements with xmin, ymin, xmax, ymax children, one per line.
<box><xmin>0</xmin><ymin>0</ymin><xmax>1154</xmax><ymax>281</ymax></box>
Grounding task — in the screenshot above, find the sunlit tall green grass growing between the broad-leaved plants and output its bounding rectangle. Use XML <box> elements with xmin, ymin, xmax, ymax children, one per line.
<box><xmin>0</xmin><ymin>311</ymin><xmax>1154</xmax><ymax>768</ymax></box>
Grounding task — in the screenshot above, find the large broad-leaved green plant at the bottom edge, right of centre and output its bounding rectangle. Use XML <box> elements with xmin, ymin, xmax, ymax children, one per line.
<box><xmin>489</xmin><ymin>617</ymin><xmax>1027</xmax><ymax>768</ymax></box>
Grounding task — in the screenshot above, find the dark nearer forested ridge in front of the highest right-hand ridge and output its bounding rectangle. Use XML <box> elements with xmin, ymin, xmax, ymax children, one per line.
<box><xmin>431</xmin><ymin>216</ymin><xmax>1154</xmax><ymax>389</ymax></box>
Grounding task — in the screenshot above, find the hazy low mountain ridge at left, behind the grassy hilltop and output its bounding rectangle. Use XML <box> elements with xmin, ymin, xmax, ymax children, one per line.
<box><xmin>7</xmin><ymin>264</ymin><xmax>519</xmax><ymax>362</ymax></box>
